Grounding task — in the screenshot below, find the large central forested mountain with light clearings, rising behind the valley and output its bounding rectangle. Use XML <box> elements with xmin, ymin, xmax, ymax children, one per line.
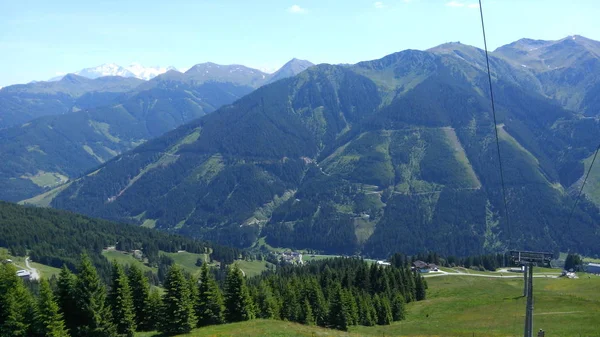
<box><xmin>39</xmin><ymin>36</ymin><xmax>600</xmax><ymax>257</ymax></box>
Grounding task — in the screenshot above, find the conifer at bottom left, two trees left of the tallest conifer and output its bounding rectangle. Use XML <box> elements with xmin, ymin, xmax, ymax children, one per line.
<box><xmin>35</xmin><ymin>279</ymin><xmax>69</xmax><ymax>337</ymax></box>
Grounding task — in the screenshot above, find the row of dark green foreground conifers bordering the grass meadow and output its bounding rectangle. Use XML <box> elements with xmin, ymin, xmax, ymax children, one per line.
<box><xmin>0</xmin><ymin>254</ymin><xmax>427</xmax><ymax>337</ymax></box>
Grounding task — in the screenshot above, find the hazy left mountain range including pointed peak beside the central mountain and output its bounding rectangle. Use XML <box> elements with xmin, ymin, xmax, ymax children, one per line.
<box><xmin>0</xmin><ymin>60</ymin><xmax>316</xmax><ymax>201</ymax></box>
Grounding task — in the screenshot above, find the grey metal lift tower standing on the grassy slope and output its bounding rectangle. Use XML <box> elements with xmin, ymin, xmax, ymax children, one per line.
<box><xmin>510</xmin><ymin>250</ymin><xmax>552</xmax><ymax>337</ymax></box>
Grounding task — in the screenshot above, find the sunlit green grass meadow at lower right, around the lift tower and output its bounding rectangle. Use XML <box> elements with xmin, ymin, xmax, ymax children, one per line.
<box><xmin>138</xmin><ymin>274</ymin><xmax>600</xmax><ymax>337</ymax></box>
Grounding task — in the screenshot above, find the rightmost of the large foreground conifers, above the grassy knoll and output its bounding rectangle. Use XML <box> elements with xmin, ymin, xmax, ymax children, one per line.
<box><xmin>225</xmin><ymin>265</ymin><xmax>254</xmax><ymax>322</ymax></box>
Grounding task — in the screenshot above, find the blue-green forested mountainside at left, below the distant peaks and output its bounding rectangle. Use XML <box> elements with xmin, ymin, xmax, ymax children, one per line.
<box><xmin>0</xmin><ymin>82</ymin><xmax>252</xmax><ymax>201</ymax></box>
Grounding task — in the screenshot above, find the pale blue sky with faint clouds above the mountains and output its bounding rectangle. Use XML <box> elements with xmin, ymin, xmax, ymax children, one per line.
<box><xmin>0</xmin><ymin>0</ymin><xmax>600</xmax><ymax>86</ymax></box>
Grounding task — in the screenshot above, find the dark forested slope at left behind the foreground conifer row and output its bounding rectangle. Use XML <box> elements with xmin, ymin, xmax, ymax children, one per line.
<box><xmin>0</xmin><ymin>201</ymin><xmax>239</xmax><ymax>275</ymax></box>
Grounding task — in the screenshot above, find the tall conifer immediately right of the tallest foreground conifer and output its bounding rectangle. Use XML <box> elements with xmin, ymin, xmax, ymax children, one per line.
<box><xmin>108</xmin><ymin>260</ymin><xmax>136</xmax><ymax>337</ymax></box>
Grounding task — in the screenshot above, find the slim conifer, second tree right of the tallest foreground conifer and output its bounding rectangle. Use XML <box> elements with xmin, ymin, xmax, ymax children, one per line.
<box><xmin>128</xmin><ymin>265</ymin><xmax>155</xmax><ymax>331</ymax></box>
